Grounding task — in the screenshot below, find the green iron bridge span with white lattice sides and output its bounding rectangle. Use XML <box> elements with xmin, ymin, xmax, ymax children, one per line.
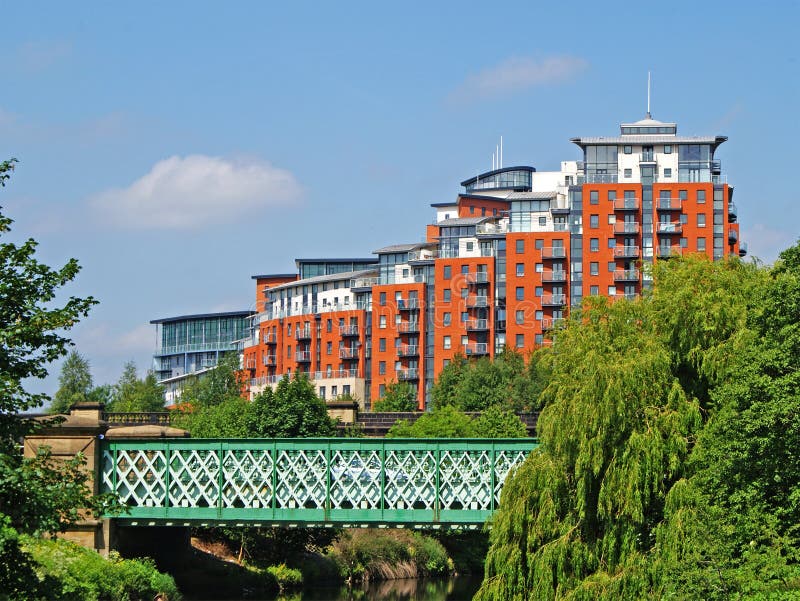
<box><xmin>100</xmin><ymin>438</ymin><xmax>537</xmax><ymax>528</ymax></box>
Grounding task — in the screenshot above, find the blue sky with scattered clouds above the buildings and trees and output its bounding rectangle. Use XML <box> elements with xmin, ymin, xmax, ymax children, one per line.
<box><xmin>0</xmin><ymin>2</ymin><xmax>800</xmax><ymax>392</ymax></box>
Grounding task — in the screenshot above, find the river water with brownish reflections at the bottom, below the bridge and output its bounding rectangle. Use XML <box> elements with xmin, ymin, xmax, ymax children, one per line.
<box><xmin>279</xmin><ymin>576</ymin><xmax>481</xmax><ymax>601</ymax></box>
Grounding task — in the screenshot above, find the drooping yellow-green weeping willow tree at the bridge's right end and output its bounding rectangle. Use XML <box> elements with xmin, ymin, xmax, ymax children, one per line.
<box><xmin>476</xmin><ymin>258</ymin><xmax>759</xmax><ymax>601</ymax></box>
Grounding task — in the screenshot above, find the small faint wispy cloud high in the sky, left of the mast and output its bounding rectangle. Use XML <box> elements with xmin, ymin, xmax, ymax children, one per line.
<box><xmin>453</xmin><ymin>56</ymin><xmax>588</xmax><ymax>100</ymax></box>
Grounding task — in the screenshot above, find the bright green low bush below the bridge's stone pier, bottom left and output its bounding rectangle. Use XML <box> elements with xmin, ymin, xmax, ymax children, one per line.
<box><xmin>22</xmin><ymin>536</ymin><xmax>181</xmax><ymax>601</ymax></box>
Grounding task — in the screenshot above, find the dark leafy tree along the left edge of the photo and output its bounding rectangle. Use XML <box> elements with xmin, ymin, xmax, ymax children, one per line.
<box><xmin>0</xmin><ymin>160</ymin><xmax>108</xmax><ymax>599</ymax></box>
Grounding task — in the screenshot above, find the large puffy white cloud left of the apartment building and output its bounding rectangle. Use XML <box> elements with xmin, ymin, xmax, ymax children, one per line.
<box><xmin>89</xmin><ymin>155</ymin><xmax>302</xmax><ymax>229</ymax></box>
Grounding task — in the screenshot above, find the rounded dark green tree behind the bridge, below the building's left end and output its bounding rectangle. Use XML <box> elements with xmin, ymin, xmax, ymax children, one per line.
<box><xmin>247</xmin><ymin>374</ymin><xmax>336</xmax><ymax>438</ymax></box>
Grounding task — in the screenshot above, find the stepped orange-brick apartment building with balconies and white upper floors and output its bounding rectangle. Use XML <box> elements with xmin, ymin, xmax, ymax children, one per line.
<box><xmin>231</xmin><ymin>114</ymin><xmax>746</xmax><ymax>409</ymax></box>
